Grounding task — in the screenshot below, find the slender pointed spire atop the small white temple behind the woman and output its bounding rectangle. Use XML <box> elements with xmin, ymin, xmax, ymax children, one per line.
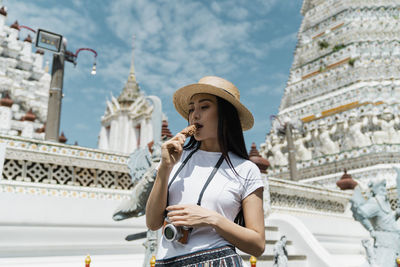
<box><xmin>118</xmin><ymin>33</ymin><xmax>140</xmax><ymax>106</ymax></box>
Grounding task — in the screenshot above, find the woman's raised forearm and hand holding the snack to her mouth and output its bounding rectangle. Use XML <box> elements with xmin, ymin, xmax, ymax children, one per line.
<box><xmin>146</xmin><ymin>133</ymin><xmax>186</xmax><ymax>231</ymax></box>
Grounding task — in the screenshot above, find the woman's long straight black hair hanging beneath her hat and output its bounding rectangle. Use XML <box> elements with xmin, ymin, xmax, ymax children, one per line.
<box><xmin>183</xmin><ymin>96</ymin><xmax>249</xmax><ymax>175</ymax></box>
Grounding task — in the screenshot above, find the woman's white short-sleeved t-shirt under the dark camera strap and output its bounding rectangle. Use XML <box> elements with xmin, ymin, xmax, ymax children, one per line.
<box><xmin>157</xmin><ymin>150</ymin><xmax>264</xmax><ymax>259</ymax></box>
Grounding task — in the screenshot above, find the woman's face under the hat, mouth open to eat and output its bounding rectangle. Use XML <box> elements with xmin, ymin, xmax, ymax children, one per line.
<box><xmin>189</xmin><ymin>94</ymin><xmax>218</xmax><ymax>141</ymax></box>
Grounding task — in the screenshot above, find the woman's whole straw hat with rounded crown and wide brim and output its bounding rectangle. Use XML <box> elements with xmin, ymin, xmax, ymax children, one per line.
<box><xmin>173</xmin><ymin>76</ymin><xmax>254</xmax><ymax>131</ymax></box>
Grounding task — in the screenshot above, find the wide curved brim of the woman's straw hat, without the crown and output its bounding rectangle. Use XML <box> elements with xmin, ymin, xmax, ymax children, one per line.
<box><xmin>173</xmin><ymin>83</ymin><xmax>254</xmax><ymax>131</ymax></box>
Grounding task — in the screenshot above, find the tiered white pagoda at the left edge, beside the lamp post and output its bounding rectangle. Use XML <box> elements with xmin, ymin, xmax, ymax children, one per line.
<box><xmin>0</xmin><ymin>7</ymin><xmax>51</xmax><ymax>140</ymax></box>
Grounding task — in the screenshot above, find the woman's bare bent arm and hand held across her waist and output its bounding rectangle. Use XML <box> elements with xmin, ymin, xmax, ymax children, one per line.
<box><xmin>167</xmin><ymin>188</ymin><xmax>265</xmax><ymax>257</ymax></box>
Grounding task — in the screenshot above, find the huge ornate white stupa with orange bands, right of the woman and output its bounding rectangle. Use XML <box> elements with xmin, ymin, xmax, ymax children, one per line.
<box><xmin>260</xmin><ymin>0</ymin><xmax>400</xmax><ymax>188</ymax></box>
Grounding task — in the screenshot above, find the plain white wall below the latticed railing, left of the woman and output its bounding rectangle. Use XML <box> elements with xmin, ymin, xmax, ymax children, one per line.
<box><xmin>0</xmin><ymin>185</ymin><xmax>146</xmax><ymax>262</ymax></box>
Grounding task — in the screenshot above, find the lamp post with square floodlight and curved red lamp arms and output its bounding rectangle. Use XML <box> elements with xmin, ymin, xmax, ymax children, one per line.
<box><xmin>30</xmin><ymin>26</ymin><xmax>97</xmax><ymax>142</ymax></box>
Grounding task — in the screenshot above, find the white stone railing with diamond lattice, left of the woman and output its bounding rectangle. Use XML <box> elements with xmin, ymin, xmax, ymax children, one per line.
<box><xmin>0</xmin><ymin>135</ymin><xmax>132</xmax><ymax>190</ymax></box>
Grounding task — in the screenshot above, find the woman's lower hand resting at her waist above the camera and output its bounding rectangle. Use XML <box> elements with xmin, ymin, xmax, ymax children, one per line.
<box><xmin>167</xmin><ymin>204</ymin><xmax>221</xmax><ymax>227</ymax></box>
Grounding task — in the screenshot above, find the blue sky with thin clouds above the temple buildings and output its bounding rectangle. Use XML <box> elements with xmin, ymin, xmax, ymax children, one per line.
<box><xmin>3</xmin><ymin>0</ymin><xmax>302</xmax><ymax>152</ymax></box>
